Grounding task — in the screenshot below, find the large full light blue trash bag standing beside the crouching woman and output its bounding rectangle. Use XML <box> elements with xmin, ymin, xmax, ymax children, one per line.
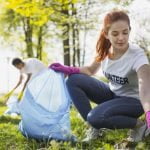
<box><xmin>19</xmin><ymin>69</ymin><xmax>75</xmax><ymax>141</ymax></box>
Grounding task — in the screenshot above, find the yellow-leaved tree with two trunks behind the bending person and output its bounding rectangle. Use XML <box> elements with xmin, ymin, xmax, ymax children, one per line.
<box><xmin>0</xmin><ymin>0</ymin><xmax>54</xmax><ymax>59</ymax></box>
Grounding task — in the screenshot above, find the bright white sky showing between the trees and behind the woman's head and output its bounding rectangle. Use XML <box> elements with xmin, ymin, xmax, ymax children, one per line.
<box><xmin>0</xmin><ymin>0</ymin><xmax>150</xmax><ymax>94</ymax></box>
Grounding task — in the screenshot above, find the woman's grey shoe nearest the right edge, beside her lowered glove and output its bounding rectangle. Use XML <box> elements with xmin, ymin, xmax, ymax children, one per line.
<box><xmin>127</xmin><ymin>123</ymin><xmax>148</xmax><ymax>142</ymax></box>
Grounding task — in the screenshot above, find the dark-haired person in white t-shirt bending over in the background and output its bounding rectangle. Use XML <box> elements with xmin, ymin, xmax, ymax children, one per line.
<box><xmin>12</xmin><ymin>58</ymin><xmax>47</xmax><ymax>97</ymax></box>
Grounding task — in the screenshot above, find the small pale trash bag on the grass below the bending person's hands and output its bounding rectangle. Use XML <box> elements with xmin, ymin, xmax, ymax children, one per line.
<box><xmin>4</xmin><ymin>96</ymin><xmax>20</xmax><ymax>115</ymax></box>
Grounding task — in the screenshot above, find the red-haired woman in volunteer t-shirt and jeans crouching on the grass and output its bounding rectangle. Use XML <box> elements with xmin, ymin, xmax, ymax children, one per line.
<box><xmin>49</xmin><ymin>10</ymin><xmax>150</xmax><ymax>141</ymax></box>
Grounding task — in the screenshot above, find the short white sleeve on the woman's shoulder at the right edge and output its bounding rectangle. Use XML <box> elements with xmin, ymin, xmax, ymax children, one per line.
<box><xmin>132</xmin><ymin>49</ymin><xmax>149</xmax><ymax>72</ymax></box>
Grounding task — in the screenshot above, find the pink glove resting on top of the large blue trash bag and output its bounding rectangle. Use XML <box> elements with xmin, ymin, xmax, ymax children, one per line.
<box><xmin>49</xmin><ymin>63</ymin><xmax>80</xmax><ymax>75</ymax></box>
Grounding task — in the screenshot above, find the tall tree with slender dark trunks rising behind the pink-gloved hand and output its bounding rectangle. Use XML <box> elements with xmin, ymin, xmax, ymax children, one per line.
<box><xmin>49</xmin><ymin>0</ymin><xmax>98</xmax><ymax>66</ymax></box>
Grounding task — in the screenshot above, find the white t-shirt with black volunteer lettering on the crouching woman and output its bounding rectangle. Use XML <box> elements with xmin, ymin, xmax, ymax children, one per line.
<box><xmin>101</xmin><ymin>44</ymin><xmax>149</xmax><ymax>99</ymax></box>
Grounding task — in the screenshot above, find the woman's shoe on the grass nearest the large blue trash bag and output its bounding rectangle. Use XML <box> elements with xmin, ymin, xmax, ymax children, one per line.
<box><xmin>82</xmin><ymin>127</ymin><xmax>103</xmax><ymax>142</ymax></box>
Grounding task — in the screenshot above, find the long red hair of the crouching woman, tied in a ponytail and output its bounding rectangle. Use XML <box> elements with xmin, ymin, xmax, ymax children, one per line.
<box><xmin>95</xmin><ymin>11</ymin><xmax>131</xmax><ymax>62</ymax></box>
